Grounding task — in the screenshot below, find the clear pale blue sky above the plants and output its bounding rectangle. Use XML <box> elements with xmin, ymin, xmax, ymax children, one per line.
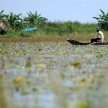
<box><xmin>0</xmin><ymin>0</ymin><xmax>108</xmax><ymax>23</ymax></box>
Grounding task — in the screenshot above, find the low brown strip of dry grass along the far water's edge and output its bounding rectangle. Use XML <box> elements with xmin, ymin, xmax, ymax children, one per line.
<box><xmin>0</xmin><ymin>34</ymin><xmax>108</xmax><ymax>43</ymax></box>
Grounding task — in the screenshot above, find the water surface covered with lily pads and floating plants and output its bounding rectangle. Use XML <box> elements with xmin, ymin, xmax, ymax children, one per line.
<box><xmin>0</xmin><ymin>42</ymin><xmax>108</xmax><ymax>108</ymax></box>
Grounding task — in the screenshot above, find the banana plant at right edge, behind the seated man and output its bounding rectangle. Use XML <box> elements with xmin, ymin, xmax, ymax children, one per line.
<box><xmin>93</xmin><ymin>9</ymin><xmax>108</xmax><ymax>30</ymax></box>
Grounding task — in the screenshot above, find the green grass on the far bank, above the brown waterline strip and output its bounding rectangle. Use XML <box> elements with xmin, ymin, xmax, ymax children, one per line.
<box><xmin>0</xmin><ymin>21</ymin><xmax>108</xmax><ymax>40</ymax></box>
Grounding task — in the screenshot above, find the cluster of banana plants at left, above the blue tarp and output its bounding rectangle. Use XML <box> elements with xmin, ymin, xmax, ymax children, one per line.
<box><xmin>0</xmin><ymin>10</ymin><xmax>47</xmax><ymax>31</ymax></box>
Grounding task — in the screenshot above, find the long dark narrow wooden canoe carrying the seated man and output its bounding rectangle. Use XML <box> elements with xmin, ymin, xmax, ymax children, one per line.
<box><xmin>67</xmin><ymin>39</ymin><xmax>108</xmax><ymax>45</ymax></box>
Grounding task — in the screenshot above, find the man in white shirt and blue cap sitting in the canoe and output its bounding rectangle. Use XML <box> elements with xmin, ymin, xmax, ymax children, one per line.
<box><xmin>91</xmin><ymin>27</ymin><xmax>104</xmax><ymax>43</ymax></box>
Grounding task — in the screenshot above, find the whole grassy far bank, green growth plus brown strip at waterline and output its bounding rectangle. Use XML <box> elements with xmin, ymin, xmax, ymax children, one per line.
<box><xmin>0</xmin><ymin>21</ymin><xmax>108</xmax><ymax>42</ymax></box>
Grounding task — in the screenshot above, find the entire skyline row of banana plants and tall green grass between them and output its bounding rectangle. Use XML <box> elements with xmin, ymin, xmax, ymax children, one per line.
<box><xmin>0</xmin><ymin>9</ymin><xmax>108</xmax><ymax>36</ymax></box>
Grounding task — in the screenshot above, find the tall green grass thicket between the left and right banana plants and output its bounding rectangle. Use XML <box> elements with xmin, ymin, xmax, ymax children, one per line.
<box><xmin>37</xmin><ymin>21</ymin><xmax>97</xmax><ymax>36</ymax></box>
